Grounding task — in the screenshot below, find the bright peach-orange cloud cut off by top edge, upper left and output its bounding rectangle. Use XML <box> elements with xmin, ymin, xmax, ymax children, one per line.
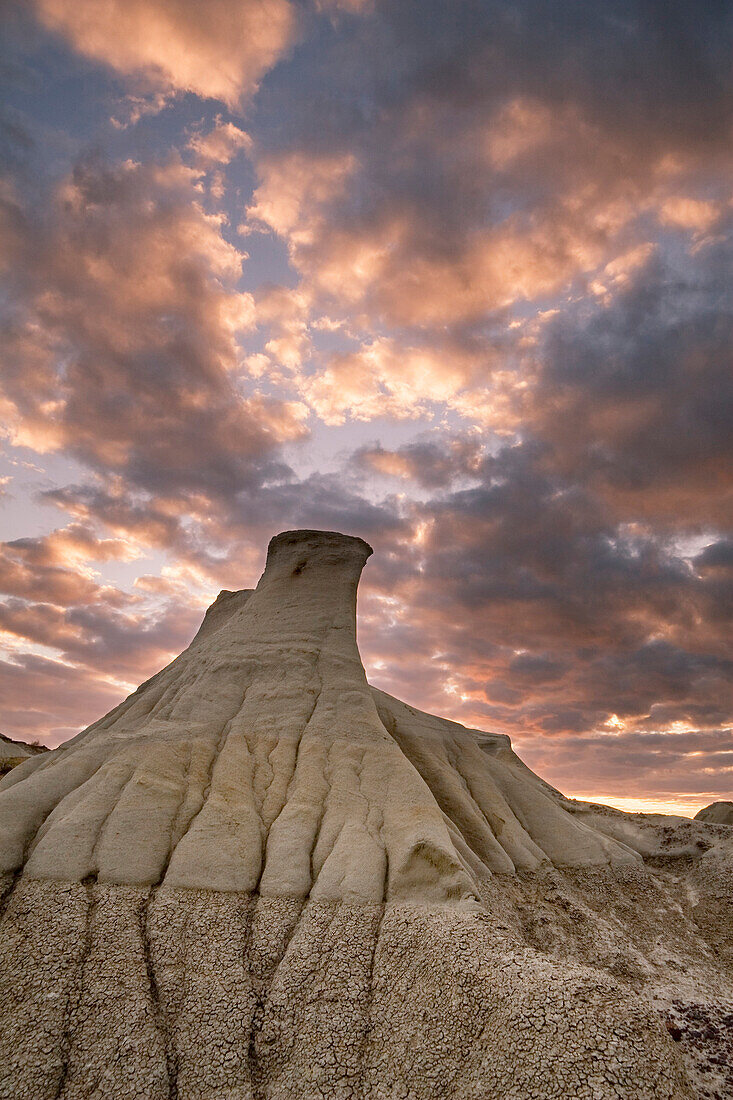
<box><xmin>34</xmin><ymin>0</ymin><xmax>296</xmax><ymax>108</ymax></box>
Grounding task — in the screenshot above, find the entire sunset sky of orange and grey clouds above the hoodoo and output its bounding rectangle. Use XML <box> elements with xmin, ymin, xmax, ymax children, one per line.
<box><xmin>0</xmin><ymin>0</ymin><xmax>733</xmax><ymax>813</ymax></box>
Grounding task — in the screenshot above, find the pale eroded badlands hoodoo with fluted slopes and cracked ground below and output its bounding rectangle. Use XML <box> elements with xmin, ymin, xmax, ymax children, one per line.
<box><xmin>0</xmin><ymin>531</ymin><xmax>733</xmax><ymax>1100</ymax></box>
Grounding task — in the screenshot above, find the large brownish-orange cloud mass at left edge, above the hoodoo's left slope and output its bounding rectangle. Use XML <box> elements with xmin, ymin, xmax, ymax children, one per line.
<box><xmin>2</xmin><ymin>151</ymin><xmax>305</xmax><ymax>495</ymax></box>
